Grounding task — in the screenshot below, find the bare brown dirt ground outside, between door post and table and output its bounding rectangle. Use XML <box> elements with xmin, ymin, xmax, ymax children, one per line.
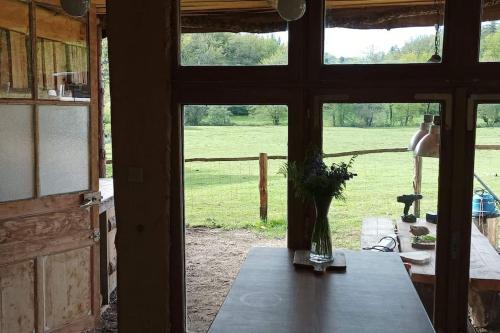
<box><xmin>89</xmin><ymin>228</ymin><xmax>286</xmax><ymax>333</ymax></box>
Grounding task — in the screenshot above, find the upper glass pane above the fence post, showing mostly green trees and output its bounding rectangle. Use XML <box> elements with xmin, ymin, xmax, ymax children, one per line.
<box><xmin>181</xmin><ymin>0</ymin><xmax>288</xmax><ymax>66</ymax></box>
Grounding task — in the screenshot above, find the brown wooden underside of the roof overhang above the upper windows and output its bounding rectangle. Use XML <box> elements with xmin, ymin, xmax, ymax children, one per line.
<box><xmin>94</xmin><ymin>0</ymin><xmax>500</xmax><ymax>32</ymax></box>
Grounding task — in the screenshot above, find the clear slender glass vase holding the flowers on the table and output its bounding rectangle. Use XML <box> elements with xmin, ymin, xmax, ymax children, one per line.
<box><xmin>309</xmin><ymin>196</ymin><xmax>333</xmax><ymax>263</ymax></box>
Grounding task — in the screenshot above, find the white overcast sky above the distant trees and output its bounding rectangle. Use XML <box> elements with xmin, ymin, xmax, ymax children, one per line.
<box><xmin>273</xmin><ymin>27</ymin><xmax>435</xmax><ymax>57</ymax></box>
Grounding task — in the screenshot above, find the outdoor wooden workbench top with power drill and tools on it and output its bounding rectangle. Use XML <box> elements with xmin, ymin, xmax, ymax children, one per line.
<box><xmin>361</xmin><ymin>217</ymin><xmax>500</xmax><ymax>291</ymax></box>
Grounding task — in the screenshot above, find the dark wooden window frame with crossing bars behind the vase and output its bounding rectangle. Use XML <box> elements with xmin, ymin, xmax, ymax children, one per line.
<box><xmin>170</xmin><ymin>0</ymin><xmax>500</xmax><ymax>332</ymax></box>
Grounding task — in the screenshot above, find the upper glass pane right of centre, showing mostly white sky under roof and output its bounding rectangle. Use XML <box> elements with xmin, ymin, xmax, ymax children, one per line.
<box><xmin>324</xmin><ymin>0</ymin><xmax>444</xmax><ymax>64</ymax></box>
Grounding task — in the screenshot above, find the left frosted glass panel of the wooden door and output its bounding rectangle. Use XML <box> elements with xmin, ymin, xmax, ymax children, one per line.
<box><xmin>0</xmin><ymin>105</ymin><xmax>35</xmax><ymax>202</ymax></box>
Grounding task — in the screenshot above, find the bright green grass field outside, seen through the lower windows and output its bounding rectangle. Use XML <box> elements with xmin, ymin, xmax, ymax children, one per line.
<box><xmin>103</xmin><ymin>122</ymin><xmax>500</xmax><ymax>249</ymax></box>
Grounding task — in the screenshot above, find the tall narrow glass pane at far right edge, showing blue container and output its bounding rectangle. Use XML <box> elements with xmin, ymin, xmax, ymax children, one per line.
<box><xmin>469</xmin><ymin>104</ymin><xmax>500</xmax><ymax>332</ymax></box>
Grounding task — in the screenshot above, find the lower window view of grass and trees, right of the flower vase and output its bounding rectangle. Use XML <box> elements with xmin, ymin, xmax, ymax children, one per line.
<box><xmin>323</xmin><ymin>103</ymin><xmax>439</xmax><ymax>249</ymax></box>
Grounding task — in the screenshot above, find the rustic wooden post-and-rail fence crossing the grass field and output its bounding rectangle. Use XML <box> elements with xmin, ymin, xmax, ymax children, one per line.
<box><xmin>106</xmin><ymin>145</ymin><xmax>500</xmax><ymax>221</ymax></box>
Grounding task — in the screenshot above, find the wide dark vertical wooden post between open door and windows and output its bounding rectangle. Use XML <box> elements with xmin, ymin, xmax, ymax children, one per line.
<box><xmin>107</xmin><ymin>0</ymin><xmax>180</xmax><ymax>333</ymax></box>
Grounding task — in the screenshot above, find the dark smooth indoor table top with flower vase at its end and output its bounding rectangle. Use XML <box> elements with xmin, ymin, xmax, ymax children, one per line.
<box><xmin>209</xmin><ymin>248</ymin><xmax>434</xmax><ymax>333</ymax></box>
